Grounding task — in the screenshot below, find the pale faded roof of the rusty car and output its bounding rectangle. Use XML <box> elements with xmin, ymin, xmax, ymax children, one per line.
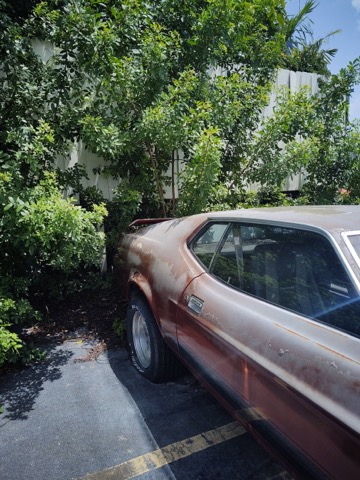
<box><xmin>207</xmin><ymin>205</ymin><xmax>360</xmax><ymax>232</ymax></box>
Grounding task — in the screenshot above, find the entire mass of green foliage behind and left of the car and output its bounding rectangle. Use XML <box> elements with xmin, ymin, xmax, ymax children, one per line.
<box><xmin>0</xmin><ymin>0</ymin><xmax>360</xmax><ymax>365</ymax></box>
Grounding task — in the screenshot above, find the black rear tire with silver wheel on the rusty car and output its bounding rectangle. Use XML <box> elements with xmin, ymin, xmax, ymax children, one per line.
<box><xmin>126</xmin><ymin>296</ymin><xmax>179</xmax><ymax>383</ymax></box>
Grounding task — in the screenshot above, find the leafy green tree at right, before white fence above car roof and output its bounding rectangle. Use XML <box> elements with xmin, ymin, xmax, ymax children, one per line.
<box><xmin>228</xmin><ymin>58</ymin><xmax>360</xmax><ymax>204</ymax></box>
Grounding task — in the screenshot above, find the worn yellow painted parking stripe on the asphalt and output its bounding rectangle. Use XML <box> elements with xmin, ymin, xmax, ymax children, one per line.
<box><xmin>78</xmin><ymin>422</ymin><xmax>246</xmax><ymax>480</ymax></box>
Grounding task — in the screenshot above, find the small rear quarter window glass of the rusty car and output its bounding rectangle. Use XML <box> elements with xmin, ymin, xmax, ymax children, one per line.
<box><xmin>191</xmin><ymin>223</ymin><xmax>228</xmax><ymax>268</ymax></box>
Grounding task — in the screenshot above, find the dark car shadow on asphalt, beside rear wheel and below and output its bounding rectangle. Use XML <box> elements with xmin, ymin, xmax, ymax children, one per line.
<box><xmin>108</xmin><ymin>351</ymin><xmax>290</xmax><ymax>480</ymax></box>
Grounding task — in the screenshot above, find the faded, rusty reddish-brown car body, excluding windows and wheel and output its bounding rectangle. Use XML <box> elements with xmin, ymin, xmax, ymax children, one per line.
<box><xmin>117</xmin><ymin>206</ymin><xmax>360</xmax><ymax>479</ymax></box>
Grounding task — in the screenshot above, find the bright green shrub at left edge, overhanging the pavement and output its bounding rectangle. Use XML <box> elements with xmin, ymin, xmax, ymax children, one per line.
<box><xmin>0</xmin><ymin>170</ymin><xmax>106</xmax><ymax>366</ymax></box>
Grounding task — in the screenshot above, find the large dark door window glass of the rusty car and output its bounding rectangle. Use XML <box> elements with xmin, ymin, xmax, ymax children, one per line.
<box><xmin>211</xmin><ymin>224</ymin><xmax>360</xmax><ymax>335</ymax></box>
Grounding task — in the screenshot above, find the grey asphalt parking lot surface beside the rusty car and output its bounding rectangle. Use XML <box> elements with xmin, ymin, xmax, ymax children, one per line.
<box><xmin>0</xmin><ymin>340</ymin><xmax>291</xmax><ymax>480</ymax></box>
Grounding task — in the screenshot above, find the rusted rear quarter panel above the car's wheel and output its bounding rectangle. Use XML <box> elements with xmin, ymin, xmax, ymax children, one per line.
<box><xmin>115</xmin><ymin>215</ymin><xmax>207</xmax><ymax>350</ymax></box>
